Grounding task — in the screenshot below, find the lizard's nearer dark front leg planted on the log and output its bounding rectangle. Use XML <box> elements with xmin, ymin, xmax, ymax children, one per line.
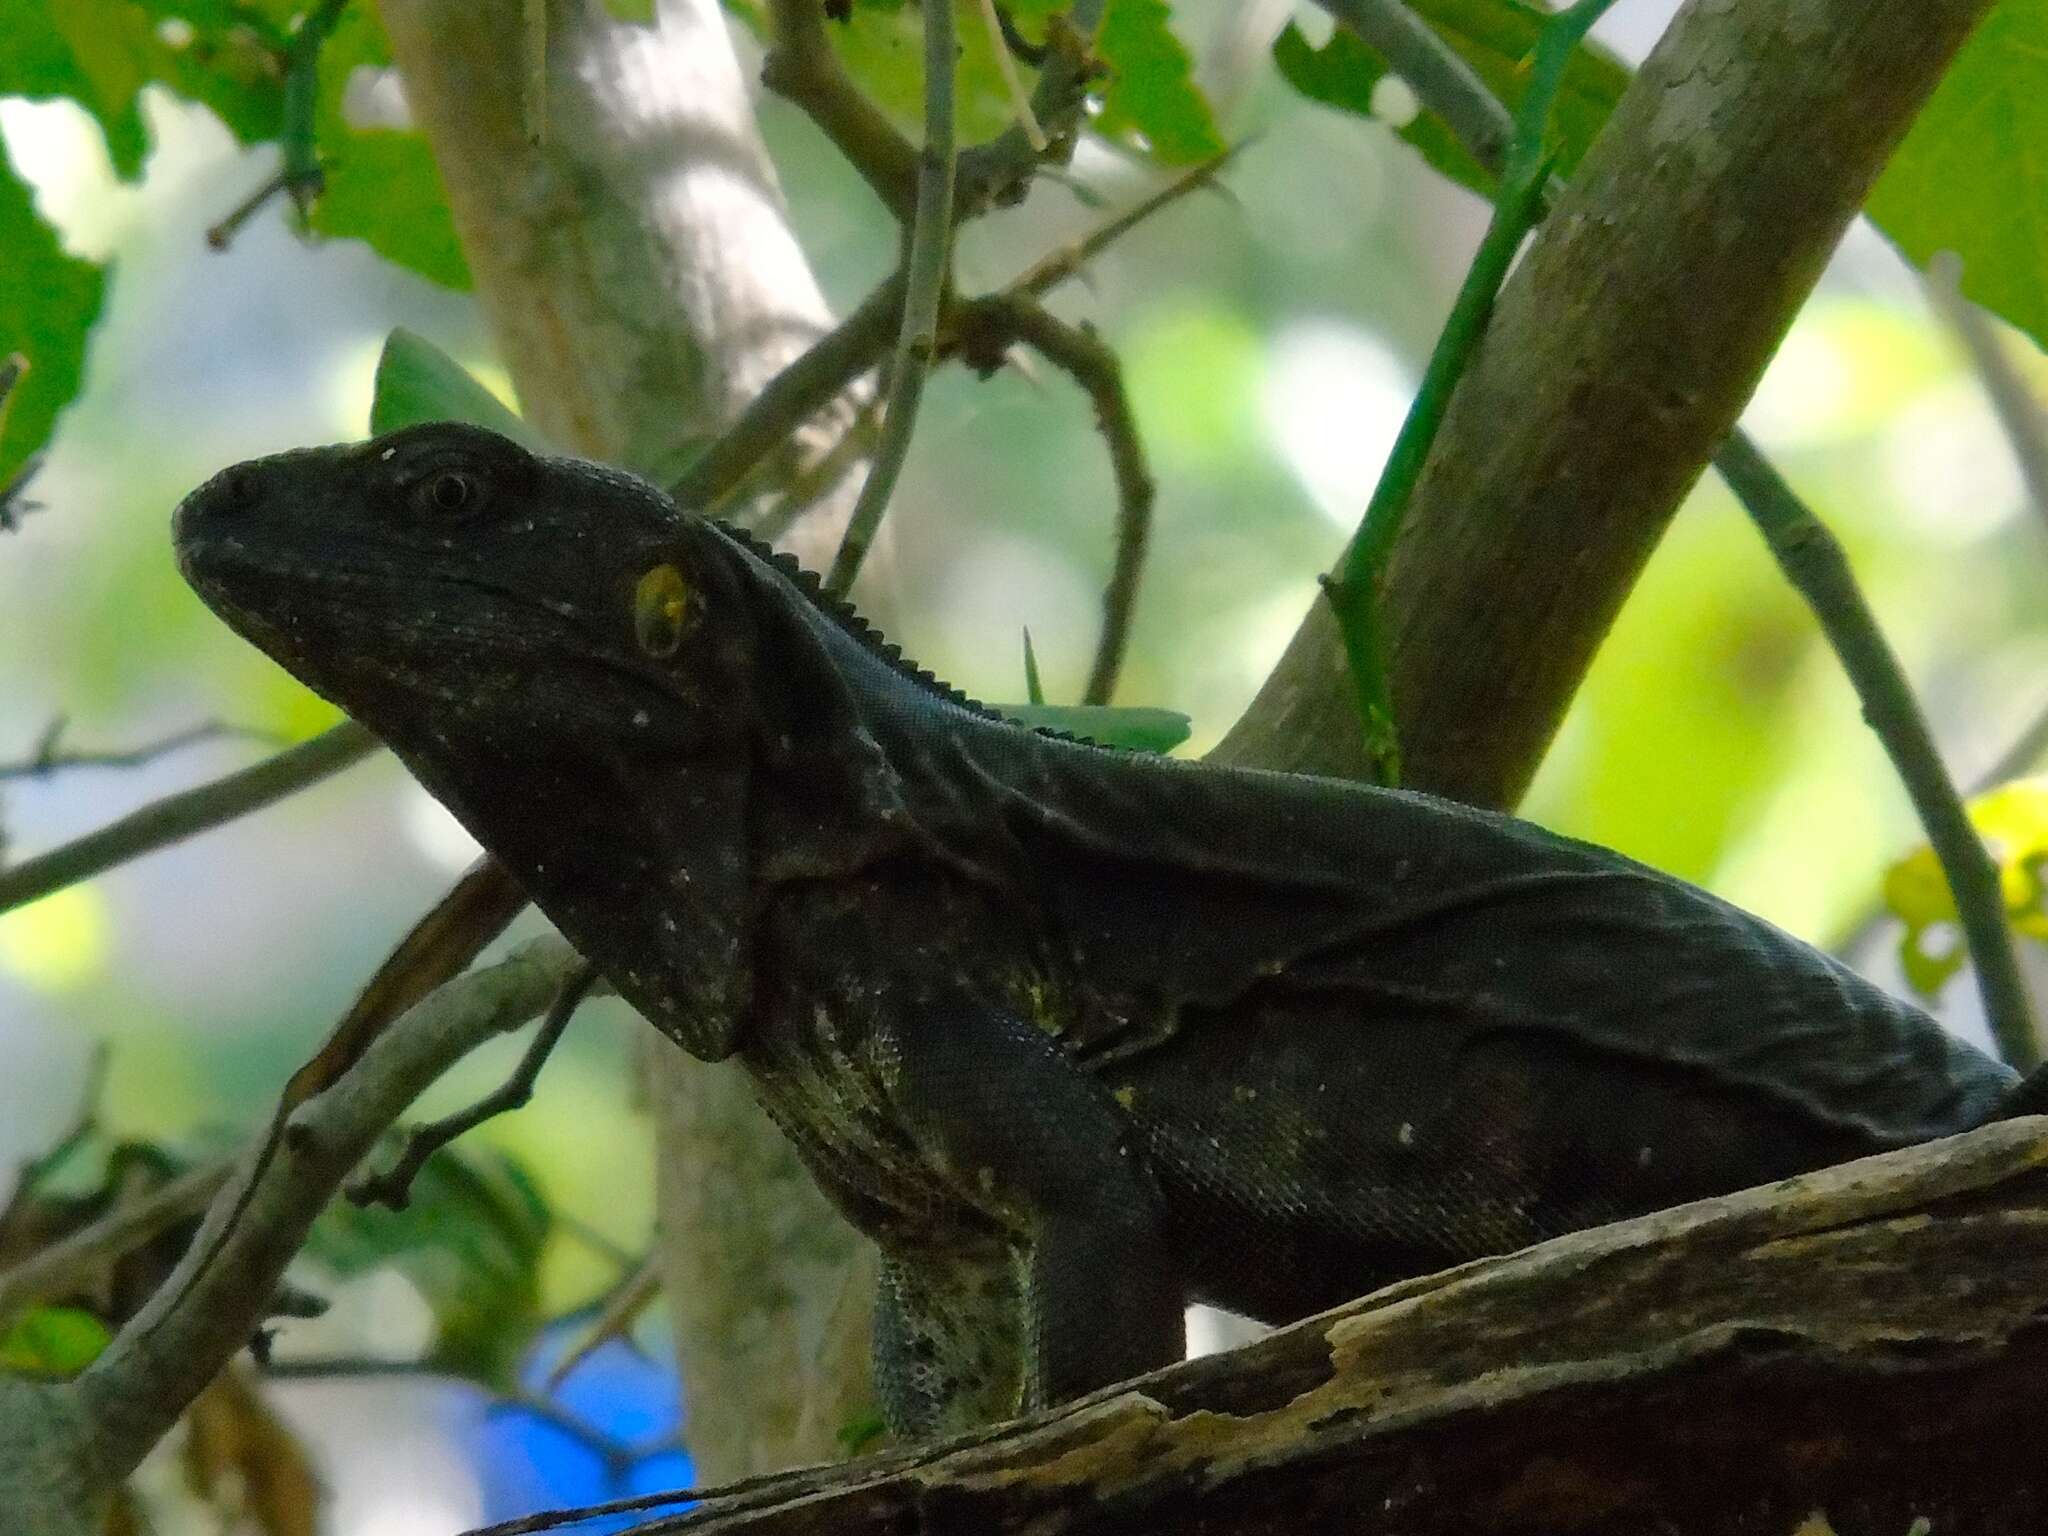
<box><xmin>881</xmin><ymin>997</ymin><xmax>1186</xmax><ymax>1419</ymax></box>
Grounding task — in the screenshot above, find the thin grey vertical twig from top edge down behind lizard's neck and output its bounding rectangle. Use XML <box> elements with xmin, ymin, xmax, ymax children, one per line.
<box><xmin>825</xmin><ymin>4</ymin><xmax>956</xmax><ymax>592</ymax></box>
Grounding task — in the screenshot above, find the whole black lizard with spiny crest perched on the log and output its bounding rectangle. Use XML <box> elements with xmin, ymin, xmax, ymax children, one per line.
<box><xmin>176</xmin><ymin>426</ymin><xmax>2015</xmax><ymax>1434</ymax></box>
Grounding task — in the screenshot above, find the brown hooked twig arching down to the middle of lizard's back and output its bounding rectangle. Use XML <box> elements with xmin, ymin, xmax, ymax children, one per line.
<box><xmin>961</xmin><ymin>293</ymin><xmax>1157</xmax><ymax>705</ymax></box>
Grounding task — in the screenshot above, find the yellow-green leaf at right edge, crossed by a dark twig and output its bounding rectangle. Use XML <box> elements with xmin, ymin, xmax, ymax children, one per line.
<box><xmin>1884</xmin><ymin>778</ymin><xmax>2048</xmax><ymax>997</ymax></box>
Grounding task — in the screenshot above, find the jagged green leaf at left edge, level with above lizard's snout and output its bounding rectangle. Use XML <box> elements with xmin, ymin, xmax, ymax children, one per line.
<box><xmin>0</xmin><ymin>145</ymin><xmax>106</xmax><ymax>485</ymax></box>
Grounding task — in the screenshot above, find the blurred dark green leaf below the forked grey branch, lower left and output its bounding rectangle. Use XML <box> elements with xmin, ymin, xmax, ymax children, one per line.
<box><xmin>307</xmin><ymin>1147</ymin><xmax>553</xmax><ymax>1386</ymax></box>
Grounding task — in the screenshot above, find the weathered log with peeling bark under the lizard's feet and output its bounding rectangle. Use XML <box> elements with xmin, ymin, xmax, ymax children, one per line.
<box><xmin>552</xmin><ymin>1120</ymin><xmax>2048</xmax><ymax>1536</ymax></box>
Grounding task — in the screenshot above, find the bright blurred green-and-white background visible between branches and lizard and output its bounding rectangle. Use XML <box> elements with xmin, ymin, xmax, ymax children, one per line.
<box><xmin>0</xmin><ymin>0</ymin><xmax>2048</xmax><ymax>1536</ymax></box>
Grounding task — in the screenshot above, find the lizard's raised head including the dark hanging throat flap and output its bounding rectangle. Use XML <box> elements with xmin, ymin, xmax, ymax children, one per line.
<box><xmin>174</xmin><ymin>424</ymin><xmax>770</xmax><ymax>1057</ymax></box>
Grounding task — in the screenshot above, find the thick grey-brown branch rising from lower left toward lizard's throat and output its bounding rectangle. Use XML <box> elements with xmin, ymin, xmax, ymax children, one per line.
<box><xmin>63</xmin><ymin>936</ymin><xmax>582</xmax><ymax>1479</ymax></box>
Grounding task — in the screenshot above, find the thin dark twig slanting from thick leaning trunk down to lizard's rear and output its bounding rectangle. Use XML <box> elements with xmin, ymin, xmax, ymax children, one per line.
<box><xmin>1714</xmin><ymin>430</ymin><xmax>2040</xmax><ymax>1071</ymax></box>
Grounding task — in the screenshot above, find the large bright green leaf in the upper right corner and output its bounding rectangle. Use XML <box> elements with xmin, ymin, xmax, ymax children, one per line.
<box><xmin>1866</xmin><ymin>0</ymin><xmax>2048</xmax><ymax>346</ymax></box>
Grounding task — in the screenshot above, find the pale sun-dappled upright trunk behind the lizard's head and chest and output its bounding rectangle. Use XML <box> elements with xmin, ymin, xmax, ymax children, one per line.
<box><xmin>381</xmin><ymin>0</ymin><xmax>866</xmax><ymax>1477</ymax></box>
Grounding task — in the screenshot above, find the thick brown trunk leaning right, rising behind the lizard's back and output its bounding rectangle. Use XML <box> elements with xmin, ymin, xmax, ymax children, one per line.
<box><xmin>1214</xmin><ymin>0</ymin><xmax>1989</xmax><ymax>807</ymax></box>
